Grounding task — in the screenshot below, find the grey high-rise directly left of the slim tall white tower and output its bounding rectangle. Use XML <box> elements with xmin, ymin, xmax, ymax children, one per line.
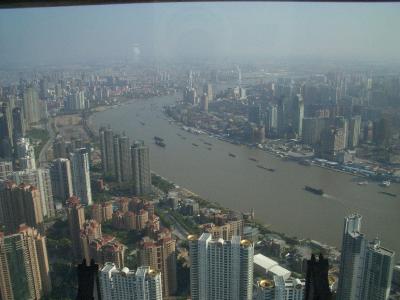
<box><xmin>50</xmin><ymin>158</ymin><xmax>73</xmax><ymax>202</ymax></box>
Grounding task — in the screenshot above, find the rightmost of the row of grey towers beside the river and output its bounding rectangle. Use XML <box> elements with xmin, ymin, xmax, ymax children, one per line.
<box><xmin>131</xmin><ymin>141</ymin><xmax>151</xmax><ymax>195</ymax></box>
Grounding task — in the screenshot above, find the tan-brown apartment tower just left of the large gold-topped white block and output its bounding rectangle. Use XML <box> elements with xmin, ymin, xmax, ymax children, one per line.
<box><xmin>139</xmin><ymin>232</ymin><xmax>177</xmax><ymax>297</ymax></box>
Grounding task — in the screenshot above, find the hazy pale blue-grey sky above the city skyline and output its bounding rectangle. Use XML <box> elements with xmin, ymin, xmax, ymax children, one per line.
<box><xmin>0</xmin><ymin>2</ymin><xmax>400</xmax><ymax>63</ymax></box>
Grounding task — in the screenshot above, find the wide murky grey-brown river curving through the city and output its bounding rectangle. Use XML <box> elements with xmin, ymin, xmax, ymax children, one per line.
<box><xmin>93</xmin><ymin>96</ymin><xmax>400</xmax><ymax>252</ymax></box>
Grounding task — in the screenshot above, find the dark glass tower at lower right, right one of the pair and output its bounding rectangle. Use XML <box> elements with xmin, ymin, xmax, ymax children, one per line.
<box><xmin>360</xmin><ymin>239</ymin><xmax>394</xmax><ymax>300</ymax></box>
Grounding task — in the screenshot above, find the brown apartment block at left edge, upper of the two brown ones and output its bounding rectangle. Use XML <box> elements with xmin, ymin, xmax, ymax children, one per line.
<box><xmin>0</xmin><ymin>182</ymin><xmax>43</xmax><ymax>232</ymax></box>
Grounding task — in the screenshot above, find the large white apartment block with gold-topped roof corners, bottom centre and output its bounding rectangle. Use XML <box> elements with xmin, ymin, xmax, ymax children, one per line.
<box><xmin>188</xmin><ymin>233</ymin><xmax>254</xmax><ymax>300</ymax></box>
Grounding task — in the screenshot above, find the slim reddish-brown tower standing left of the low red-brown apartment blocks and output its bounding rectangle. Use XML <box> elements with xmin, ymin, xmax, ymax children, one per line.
<box><xmin>66</xmin><ymin>197</ymin><xmax>85</xmax><ymax>258</ymax></box>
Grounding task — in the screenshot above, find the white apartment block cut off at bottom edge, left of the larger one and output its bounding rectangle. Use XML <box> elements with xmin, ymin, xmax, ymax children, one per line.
<box><xmin>99</xmin><ymin>263</ymin><xmax>163</xmax><ymax>300</ymax></box>
